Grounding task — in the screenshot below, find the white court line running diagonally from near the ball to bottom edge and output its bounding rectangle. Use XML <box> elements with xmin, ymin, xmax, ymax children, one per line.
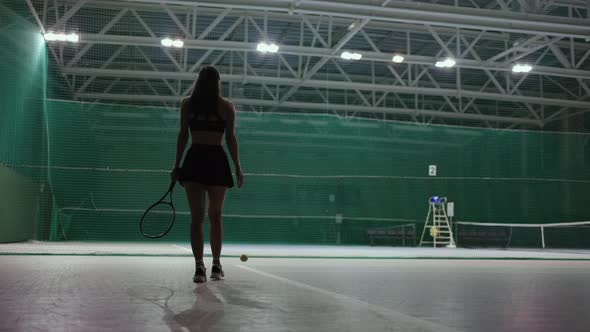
<box><xmin>235</xmin><ymin>265</ymin><xmax>457</xmax><ymax>332</ymax></box>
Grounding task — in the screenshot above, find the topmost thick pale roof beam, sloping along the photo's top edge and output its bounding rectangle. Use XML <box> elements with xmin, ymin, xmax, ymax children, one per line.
<box><xmin>105</xmin><ymin>0</ymin><xmax>590</xmax><ymax>38</ymax></box>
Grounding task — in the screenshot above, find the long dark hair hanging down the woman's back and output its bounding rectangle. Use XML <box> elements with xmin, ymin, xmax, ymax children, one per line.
<box><xmin>189</xmin><ymin>66</ymin><xmax>221</xmax><ymax>118</ymax></box>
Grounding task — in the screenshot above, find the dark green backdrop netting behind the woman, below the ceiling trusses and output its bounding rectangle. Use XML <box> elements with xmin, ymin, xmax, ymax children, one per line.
<box><xmin>30</xmin><ymin>100</ymin><xmax>590</xmax><ymax>245</ymax></box>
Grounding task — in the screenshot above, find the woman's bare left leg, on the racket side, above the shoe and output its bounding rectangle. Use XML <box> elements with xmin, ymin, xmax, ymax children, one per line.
<box><xmin>184</xmin><ymin>182</ymin><xmax>206</xmax><ymax>263</ymax></box>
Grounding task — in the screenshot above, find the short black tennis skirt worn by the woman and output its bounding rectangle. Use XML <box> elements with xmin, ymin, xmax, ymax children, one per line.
<box><xmin>179</xmin><ymin>144</ymin><xmax>234</xmax><ymax>188</ymax></box>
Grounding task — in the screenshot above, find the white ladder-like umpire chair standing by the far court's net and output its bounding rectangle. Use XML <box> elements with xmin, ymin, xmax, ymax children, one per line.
<box><xmin>420</xmin><ymin>196</ymin><xmax>456</xmax><ymax>248</ymax></box>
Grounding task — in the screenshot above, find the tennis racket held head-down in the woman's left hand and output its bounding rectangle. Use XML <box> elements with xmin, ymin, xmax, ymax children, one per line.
<box><xmin>139</xmin><ymin>181</ymin><xmax>176</xmax><ymax>239</ymax></box>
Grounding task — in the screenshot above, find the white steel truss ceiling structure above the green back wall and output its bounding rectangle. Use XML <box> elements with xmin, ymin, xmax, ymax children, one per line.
<box><xmin>26</xmin><ymin>0</ymin><xmax>590</xmax><ymax>129</ymax></box>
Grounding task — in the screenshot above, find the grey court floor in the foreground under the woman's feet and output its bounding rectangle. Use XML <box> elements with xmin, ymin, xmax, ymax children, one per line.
<box><xmin>0</xmin><ymin>255</ymin><xmax>590</xmax><ymax>332</ymax></box>
